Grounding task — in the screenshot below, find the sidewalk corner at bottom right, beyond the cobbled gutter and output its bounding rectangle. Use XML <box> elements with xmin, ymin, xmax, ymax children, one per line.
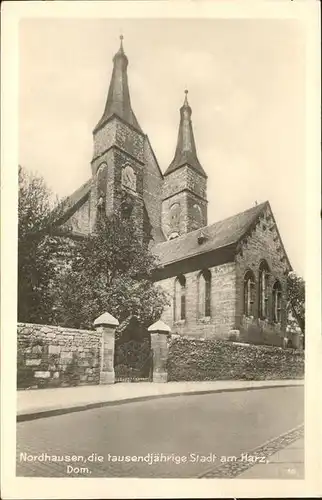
<box><xmin>238</xmin><ymin>437</ymin><xmax>304</xmax><ymax>479</ymax></box>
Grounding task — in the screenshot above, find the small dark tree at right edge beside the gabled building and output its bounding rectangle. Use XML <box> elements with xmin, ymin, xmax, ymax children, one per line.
<box><xmin>287</xmin><ymin>271</ymin><xmax>305</xmax><ymax>334</ymax></box>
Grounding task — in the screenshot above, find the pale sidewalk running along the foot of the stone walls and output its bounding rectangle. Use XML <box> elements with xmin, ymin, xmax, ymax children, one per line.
<box><xmin>17</xmin><ymin>380</ymin><xmax>304</xmax><ymax>421</ymax></box>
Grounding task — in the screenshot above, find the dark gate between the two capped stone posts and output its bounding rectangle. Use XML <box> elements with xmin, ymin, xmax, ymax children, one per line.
<box><xmin>114</xmin><ymin>338</ymin><xmax>153</xmax><ymax>382</ymax></box>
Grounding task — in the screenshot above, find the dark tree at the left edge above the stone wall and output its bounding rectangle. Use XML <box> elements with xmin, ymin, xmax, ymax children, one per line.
<box><xmin>18</xmin><ymin>166</ymin><xmax>64</xmax><ymax>323</ymax></box>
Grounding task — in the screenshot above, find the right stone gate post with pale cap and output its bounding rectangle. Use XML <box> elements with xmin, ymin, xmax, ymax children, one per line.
<box><xmin>148</xmin><ymin>321</ymin><xmax>171</xmax><ymax>382</ymax></box>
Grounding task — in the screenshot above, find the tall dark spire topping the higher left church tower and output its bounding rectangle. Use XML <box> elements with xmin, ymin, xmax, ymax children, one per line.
<box><xmin>94</xmin><ymin>35</ymin><xmax>142</xmax><ymax>132</ymax></box>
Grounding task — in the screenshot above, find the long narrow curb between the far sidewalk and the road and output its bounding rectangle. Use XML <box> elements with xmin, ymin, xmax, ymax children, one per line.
<box><xmin>17</xmin><ymin>383</ymin><xmax>304</xmax><ymax>422</ymax></box>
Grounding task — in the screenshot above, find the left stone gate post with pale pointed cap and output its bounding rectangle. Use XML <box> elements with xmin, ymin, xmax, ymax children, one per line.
<box><xmin>94</xmin><ymin>312</ymin><xmax>119</xmax><ymax>384</ymax></box>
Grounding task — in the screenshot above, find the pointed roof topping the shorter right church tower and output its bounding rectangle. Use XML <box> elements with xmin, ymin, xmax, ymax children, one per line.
<box><xmin>164</xmin><ymin>90</ymin><xmax>207</xmax><ymax>177</ymax></box>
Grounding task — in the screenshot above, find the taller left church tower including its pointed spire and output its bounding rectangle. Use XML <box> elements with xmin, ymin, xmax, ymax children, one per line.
<box><xmin>90</xmin><ymin>36</ymin><xmax>145</xmax><ymax>236</ymax></box>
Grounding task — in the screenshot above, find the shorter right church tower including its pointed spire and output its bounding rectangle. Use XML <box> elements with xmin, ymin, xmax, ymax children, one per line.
<box><xmin>162</xmin><ymin>90</ymin><xmax>207</xmax><ymax>239</ymax></box>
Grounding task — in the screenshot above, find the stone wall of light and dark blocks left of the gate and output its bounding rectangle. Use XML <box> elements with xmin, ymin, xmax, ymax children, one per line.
<box><xmin>17</xmin><ymin>323</ymin><xmax>101</xmax><ymax>388</ymax></box>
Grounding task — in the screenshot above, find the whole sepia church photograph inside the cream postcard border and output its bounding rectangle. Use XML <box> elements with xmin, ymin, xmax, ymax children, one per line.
<box><xmin>3</xmin><ymin>2</ymin><xmax>320</xmax><ymax>498</ymax></box>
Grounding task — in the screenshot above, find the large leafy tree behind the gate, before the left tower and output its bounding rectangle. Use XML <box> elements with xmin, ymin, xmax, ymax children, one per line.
<box><xmin>53</xmin><ymin>205</ymin><xmax>168</xmax><ymax>328</ymax></box>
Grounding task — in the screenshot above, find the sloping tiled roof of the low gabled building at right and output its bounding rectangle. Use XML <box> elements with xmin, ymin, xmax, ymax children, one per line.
<box><xmin>153</xmin><ymin>201</ymin><xmax>268</xmax><ymax>265</ymax></box>
